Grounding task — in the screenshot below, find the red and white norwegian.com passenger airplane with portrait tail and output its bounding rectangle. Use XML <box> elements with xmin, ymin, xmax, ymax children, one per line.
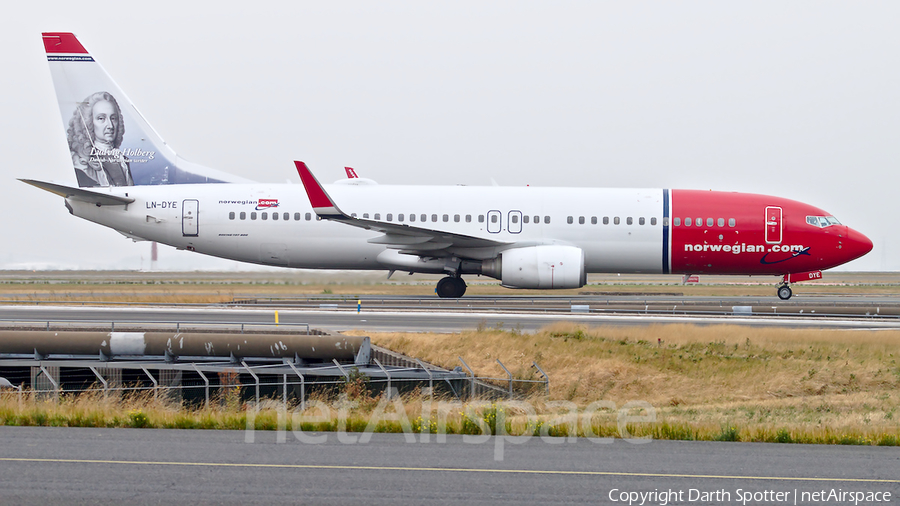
<box><xmin>22</xmin><ymin>32</ymin><xmax>872</xmax><ymax>300</ymax></box>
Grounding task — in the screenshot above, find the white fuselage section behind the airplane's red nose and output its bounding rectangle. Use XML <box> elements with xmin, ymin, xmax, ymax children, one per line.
<box><xmin>68</xmin><ymin>184</ymin><xmax>664</xmax><ymax>273</ymax></box>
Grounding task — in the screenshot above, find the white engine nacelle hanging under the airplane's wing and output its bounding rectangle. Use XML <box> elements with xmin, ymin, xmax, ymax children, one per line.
<box><xmin>482</xmin><ymin>245</ymin><xmax>587</xmax><ymax>288</ymax></box>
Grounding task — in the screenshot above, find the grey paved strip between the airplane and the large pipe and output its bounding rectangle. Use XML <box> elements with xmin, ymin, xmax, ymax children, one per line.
<box><xmin>0</xmin><ymin>305</ymin><xmax>900</xmax><ymax>332</ymax></box>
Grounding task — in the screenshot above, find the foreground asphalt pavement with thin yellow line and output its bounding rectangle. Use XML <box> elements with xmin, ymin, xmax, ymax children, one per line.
<box><xmin>0</xmin><ymin>427</ymin><xmax>900</xmax><ymax>505</ymax></box>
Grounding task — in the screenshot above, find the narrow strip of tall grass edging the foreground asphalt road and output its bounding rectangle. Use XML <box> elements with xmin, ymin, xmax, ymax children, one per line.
<box><xmin>0</xmin><ymin>392</ymin><xmax>900</xmax><ymax>446</ymax></box>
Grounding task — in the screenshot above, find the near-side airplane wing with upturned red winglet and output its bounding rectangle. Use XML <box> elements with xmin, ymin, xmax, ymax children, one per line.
<box><xmin>294</xmin><ymin>161</ymin><xmax>510</xmax><ymax>256</ymax></box>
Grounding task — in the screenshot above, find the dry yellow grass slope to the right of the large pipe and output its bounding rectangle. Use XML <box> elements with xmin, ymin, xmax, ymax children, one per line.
<box><xmin>369</xmin><ymin>324</ymin><xmax>900</xmax><ymax>434</ymax></box>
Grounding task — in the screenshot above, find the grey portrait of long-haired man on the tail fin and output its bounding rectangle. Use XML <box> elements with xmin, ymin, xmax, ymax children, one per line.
<box><xmin>66</xmin><ymin>91</ymin><xmax>134</xmax><ymax>187</ymax></box>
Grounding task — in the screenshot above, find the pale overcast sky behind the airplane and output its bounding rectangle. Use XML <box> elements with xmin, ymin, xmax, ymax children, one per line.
<box><xmin>0</xmin><ymin>0</ymin><xmax>900</xmax><ymax>270</ymax></box>
